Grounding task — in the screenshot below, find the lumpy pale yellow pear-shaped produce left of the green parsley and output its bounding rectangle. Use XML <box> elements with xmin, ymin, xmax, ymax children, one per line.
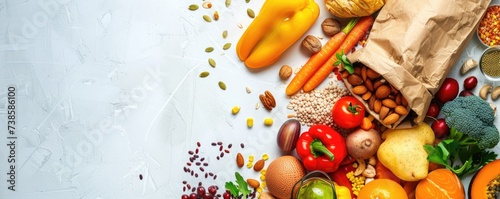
<box><xmin>377</xmin><ymin>123</ymin><xmax>435</xmax><ymax>181</ymax></box>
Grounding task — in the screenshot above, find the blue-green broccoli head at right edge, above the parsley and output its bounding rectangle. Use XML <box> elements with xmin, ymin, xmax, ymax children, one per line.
<box><xmin>441</xmin><ymin>96</ymin><xmax>500</xmax><ymax>149</ymax></box>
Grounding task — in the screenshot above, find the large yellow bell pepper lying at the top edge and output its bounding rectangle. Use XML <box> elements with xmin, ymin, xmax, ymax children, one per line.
<box><xmin>236</xmin><ymin>0</ymin><xmax>320</xmax><ymax>68</ymax></box>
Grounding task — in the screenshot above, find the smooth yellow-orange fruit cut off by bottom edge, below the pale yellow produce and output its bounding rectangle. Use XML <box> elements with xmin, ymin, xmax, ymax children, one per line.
<box><xmin>358</xmin><ymin>179</ymin><xmax>408</xmax><ymax>199</ymax></box>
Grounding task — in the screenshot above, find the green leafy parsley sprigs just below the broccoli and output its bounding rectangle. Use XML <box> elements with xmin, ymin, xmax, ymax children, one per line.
<box><xmin>424</xmin><ymin>129</ymin><xmax>497</xmax><ymax>178</ymax></box>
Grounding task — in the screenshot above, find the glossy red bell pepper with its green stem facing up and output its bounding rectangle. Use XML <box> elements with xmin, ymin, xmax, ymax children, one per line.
<box><xmin>296</xmin><ymin>125</ymin><xmax>347</xmax><ymax>173</ymax></box>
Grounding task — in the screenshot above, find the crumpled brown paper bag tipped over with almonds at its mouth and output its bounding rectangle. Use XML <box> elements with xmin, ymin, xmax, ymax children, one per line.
<box><xmin>347</xmin><ymin>0</ymin><xmax>490</xmax><ymax>128</ymax></box>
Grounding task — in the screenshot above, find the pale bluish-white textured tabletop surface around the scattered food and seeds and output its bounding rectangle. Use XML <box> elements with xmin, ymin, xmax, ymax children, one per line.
<box><xmin>0</xmin><ymin>0</ymin><xmax>500</xmax><ymax>199</ymax></box>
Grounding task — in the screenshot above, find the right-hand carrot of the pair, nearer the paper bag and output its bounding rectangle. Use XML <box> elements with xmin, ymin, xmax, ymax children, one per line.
<box><xmin>303</xmin><ymin>15</ymin><xmax>374</xmax><ymax>92</ymax></box>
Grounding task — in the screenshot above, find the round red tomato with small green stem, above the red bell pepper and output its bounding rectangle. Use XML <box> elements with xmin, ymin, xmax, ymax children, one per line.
<box><xmin>332</xmin><ymin>96</ymin><xmax>365</xmax><ymax>129</ymax></box>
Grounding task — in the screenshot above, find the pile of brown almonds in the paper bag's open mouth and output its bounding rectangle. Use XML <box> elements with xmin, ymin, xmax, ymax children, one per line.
<box><xmin>342</xmin><ymin>63</ymin><xmax>409</xmax><ymax>125</ymax></box>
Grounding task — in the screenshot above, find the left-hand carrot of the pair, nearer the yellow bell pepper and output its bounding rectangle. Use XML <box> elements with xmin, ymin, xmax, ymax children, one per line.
<box><xmin>286</xmin><ymin>18</ymin><xmax>359</xmax><ymax>95</ymax></box>
